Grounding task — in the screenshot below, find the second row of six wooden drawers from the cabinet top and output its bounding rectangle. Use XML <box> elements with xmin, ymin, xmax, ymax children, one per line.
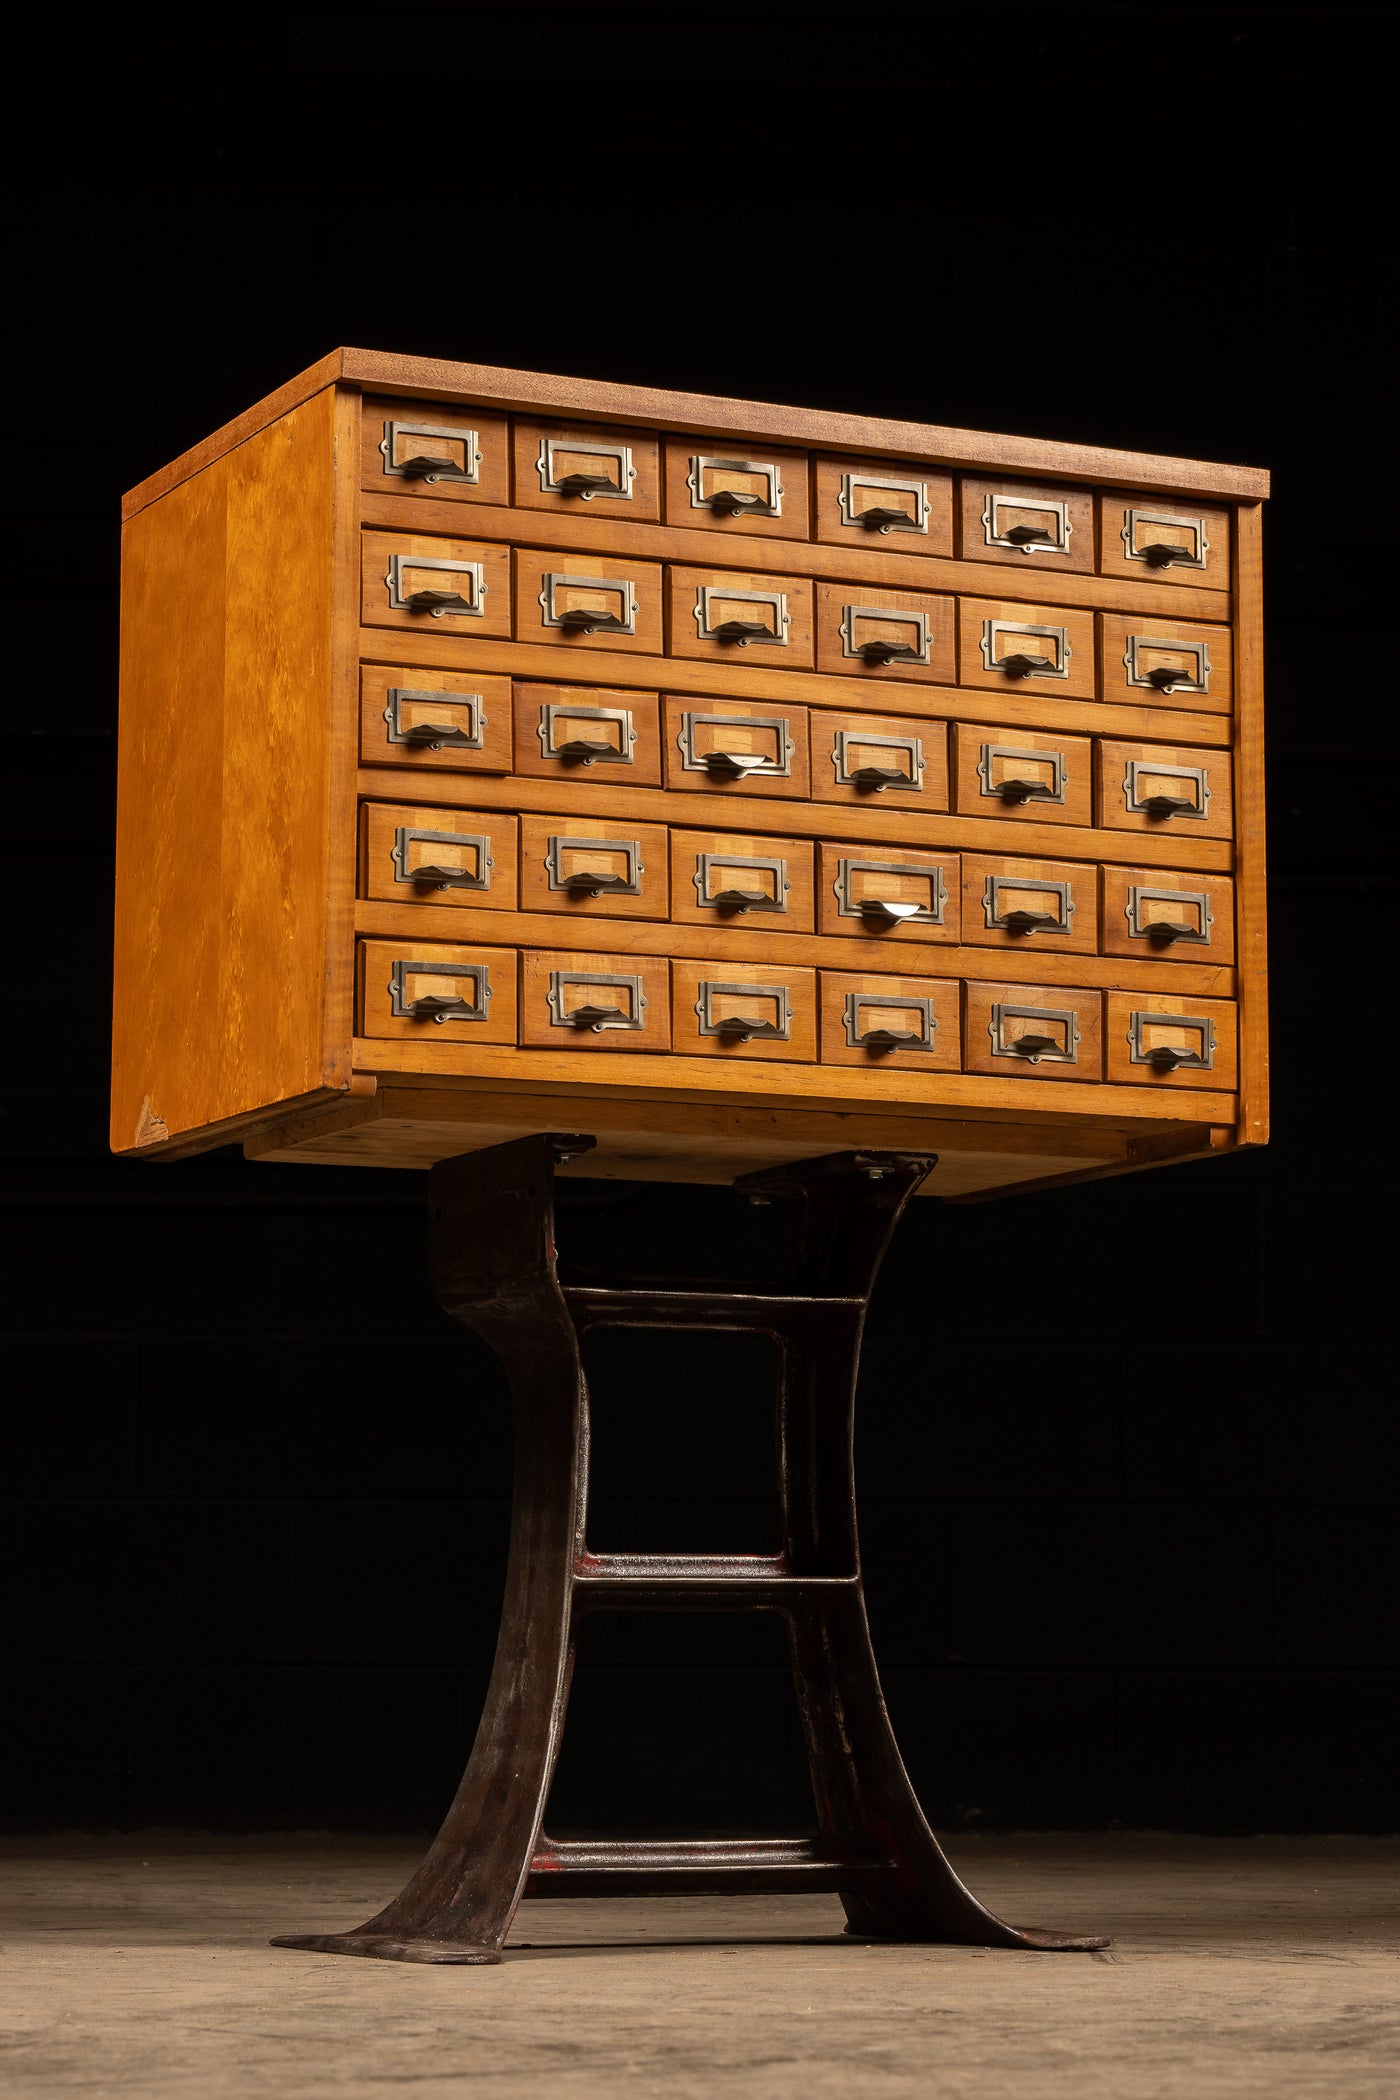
<box><xmin>361</xmin><ymin>531</ymin><xmax>1232</xmax><ymax>714</ymax></box>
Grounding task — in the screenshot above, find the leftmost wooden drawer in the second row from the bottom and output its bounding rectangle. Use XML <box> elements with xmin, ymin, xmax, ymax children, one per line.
<box><xmin>359</xmin><ymin>802</ymin><xmax>516</xmax><ymax>911</ymax></box>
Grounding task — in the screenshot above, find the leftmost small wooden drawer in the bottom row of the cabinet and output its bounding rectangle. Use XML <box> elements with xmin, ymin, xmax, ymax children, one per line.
<box><xmin>359</xmin><ymin>941</ymin><xmax>516</xmax><ymax>1044</ymax></box>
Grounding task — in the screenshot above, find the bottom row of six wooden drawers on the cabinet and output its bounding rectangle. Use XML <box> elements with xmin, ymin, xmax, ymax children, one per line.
<box><xmin>359</xmin><ymin>941</ymin><xmax>1236</xmax><ymax>1092</ymax></box>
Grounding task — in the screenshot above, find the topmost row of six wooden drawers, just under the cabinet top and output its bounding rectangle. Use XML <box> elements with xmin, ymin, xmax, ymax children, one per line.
<box><xmin>361</xmin><ymin>401</ymin><xmax>1230</xmax><ymax>590</ymax></box>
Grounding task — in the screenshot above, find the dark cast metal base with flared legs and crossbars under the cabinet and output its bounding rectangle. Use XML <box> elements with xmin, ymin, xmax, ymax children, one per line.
<box><xmin>273</xmin><ymin>1136</ymin><xmax>1108</xmax><ymax>1964</ymax></box>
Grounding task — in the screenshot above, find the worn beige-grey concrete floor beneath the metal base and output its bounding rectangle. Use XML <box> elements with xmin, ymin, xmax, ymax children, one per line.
<box><xmin>0</xmin><ymin>1838</ymin><xmax>1400</xmax><ymax>2100</ymax></box>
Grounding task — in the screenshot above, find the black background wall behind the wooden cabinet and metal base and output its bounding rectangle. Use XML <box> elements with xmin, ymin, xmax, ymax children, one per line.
<box><xmin>0</xmin><ymin>0</ymin><xmax>1400</xmax><ymax>1829</ymax></box>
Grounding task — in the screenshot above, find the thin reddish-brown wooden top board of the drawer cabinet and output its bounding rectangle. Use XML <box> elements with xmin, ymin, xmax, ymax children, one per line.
<box><xmin>122</xmin><ymin>349</ymin><xmax>1270</xmax><ymax>517</ymax></box>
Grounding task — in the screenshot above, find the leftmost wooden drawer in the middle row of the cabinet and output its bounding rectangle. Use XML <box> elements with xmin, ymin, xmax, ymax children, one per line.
<box><xmin>359</xmin><ymin>664</ymin><xmax>510</xmax><ymax>773</ymax></box>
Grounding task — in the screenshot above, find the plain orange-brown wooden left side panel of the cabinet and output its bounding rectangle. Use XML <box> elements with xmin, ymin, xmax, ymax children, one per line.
<box><xmin>111</xmin><ymin>391</ymin><xmax>334</xmax><ymax>1151</ymax></box>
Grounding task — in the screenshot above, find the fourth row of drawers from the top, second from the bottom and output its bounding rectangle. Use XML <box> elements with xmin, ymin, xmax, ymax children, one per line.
<box><xmin>359</xmin><ymin>802</ymin><xmax>1234</xmax><ymax>964</ymax></box>
